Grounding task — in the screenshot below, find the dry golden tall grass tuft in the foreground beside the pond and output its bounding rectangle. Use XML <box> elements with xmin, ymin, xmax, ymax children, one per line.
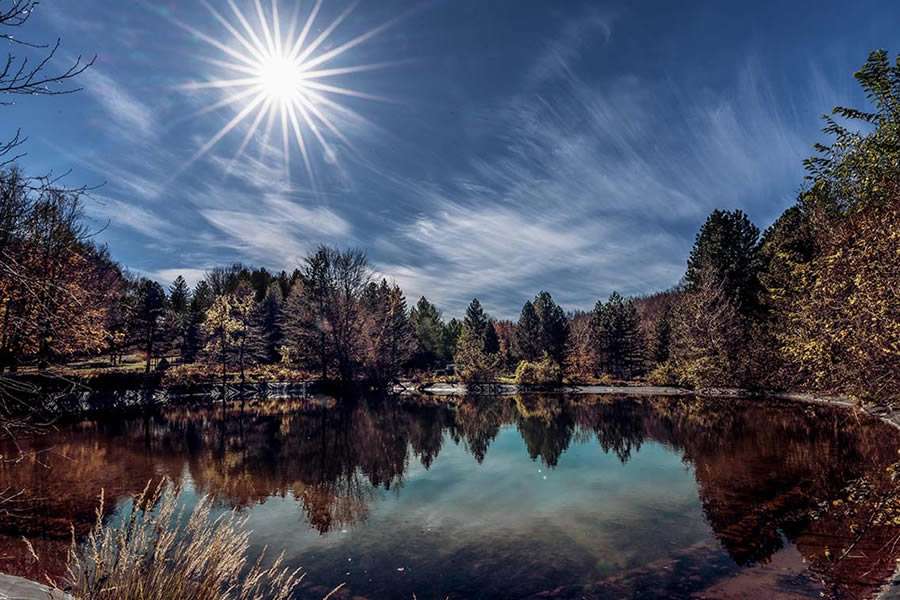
<box><xmin>61</xmin><ymin>481</ymin><xmax>316</xmax><ymax>600</ymax></box>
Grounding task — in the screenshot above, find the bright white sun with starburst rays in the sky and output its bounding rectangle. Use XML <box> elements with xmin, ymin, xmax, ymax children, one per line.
<box><xmin>172</xmin><ymin>0</ymin><xmax>404</xmax><ymax>185</ymax></box>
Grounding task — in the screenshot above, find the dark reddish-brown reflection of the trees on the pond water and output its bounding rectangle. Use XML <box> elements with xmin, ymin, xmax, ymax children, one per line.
<box><xmin>0</xmin><ymin>395</ymin><xmax>900</xmax><ymax>598</ymax></box>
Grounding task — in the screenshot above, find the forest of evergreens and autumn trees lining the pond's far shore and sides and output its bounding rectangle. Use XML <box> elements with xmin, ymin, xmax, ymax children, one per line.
<box><xmin>0</xmin><ymin>50</ymin><xmax>900</xmax><ymax>402</ymax></box>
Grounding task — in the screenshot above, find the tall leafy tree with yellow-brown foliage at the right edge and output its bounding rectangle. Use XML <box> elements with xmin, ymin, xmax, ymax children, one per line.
<box><xmin>764</xmin><ymin>50</ymin><xmax>900</xmax><ymax>401</ymax></box>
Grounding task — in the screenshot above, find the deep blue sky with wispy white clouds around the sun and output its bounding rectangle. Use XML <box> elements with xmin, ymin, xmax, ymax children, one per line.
<box><xmin>3</xmin><ymin>0</ymin><xmax>900</xmax><ymax>317</ymax></box>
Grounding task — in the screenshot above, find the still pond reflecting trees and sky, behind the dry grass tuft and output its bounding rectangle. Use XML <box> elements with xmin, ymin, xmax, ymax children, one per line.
<box><xmin>0</xmin><ymin>395</ymin><xmax>900</xmax><ymax>600</ymax></box>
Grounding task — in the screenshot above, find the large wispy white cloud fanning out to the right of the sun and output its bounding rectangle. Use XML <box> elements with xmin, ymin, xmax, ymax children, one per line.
<box><xmin>378</xmin><ymin>15</ymin><xmax>808</xmax><ymax>317</ymax></box>
